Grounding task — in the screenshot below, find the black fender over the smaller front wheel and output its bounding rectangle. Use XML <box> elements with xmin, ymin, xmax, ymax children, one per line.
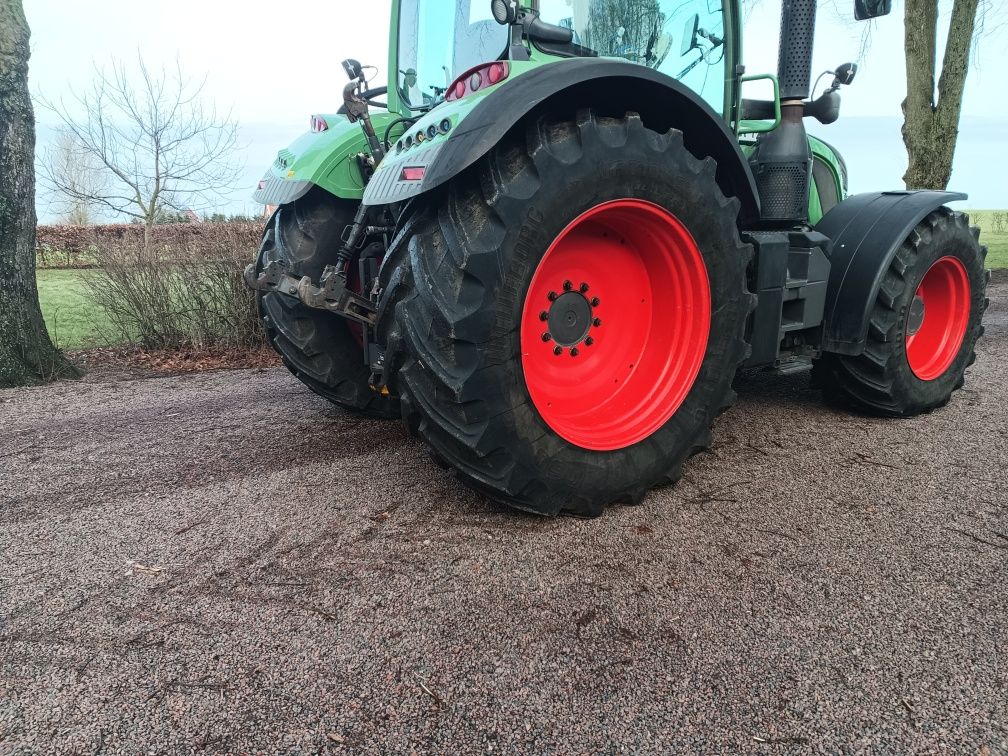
<box><xmin>815</xmin><ymin>190</ymin><xmax>967</xmax><ymax>355</ymax></box>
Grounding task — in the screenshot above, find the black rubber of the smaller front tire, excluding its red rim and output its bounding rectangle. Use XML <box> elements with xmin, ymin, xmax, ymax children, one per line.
<box><xmin>812</xmin><ymin>208</ymin><xmax>990</xmax><ymax>417</ymax></box>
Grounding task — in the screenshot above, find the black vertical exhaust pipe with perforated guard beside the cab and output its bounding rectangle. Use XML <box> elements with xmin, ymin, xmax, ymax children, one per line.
<box><xmin>750</xmin><ymin>0</ymin><xmax>815</xmax><ymax>227</ymax></box>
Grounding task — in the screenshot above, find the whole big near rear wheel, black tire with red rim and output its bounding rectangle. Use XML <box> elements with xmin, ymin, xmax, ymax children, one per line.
<box><xmin>379</xmin><ymin>111</ymin><xmax>755</xmax><ymax>516</ymax></box>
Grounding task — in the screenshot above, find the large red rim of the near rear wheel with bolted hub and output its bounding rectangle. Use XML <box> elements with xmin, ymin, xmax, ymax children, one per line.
<box><xmin>521</xmin><ymin>200</ymin><xmax>711</xmax><ymax>452</ymax></box>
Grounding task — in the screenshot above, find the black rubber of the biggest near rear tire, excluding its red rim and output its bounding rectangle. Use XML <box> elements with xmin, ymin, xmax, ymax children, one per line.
<box><xmin>379</xmin><ymin>111</ymin><xmax>755</xmax><ymax>516</ymax></box>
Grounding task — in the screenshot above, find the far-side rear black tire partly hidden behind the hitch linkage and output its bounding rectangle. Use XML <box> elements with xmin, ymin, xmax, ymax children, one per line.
<box><xmin>256</xmin><ymin>187</ymin><xmax>400</xmax><ymax>418</ymax></box>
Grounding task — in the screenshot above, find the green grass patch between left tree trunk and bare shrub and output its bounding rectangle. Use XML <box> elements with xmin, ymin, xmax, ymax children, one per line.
<box><xmin>36</xmin><ymin>270</ymin><xmax>111</xmax><ymax>349</ymax></box>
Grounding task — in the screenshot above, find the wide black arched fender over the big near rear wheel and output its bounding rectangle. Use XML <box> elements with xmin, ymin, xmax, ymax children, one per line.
<box><xmin>364</xmin><ymin>57</ymin><xmax>760</xmax><ymax>222</ymax></box>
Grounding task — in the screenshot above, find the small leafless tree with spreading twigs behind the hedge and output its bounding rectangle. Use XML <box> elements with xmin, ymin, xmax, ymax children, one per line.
<box><xmin>42</xmin><ymin>56</ymin><xmax>241</xmax><ymax>245</ymax></box>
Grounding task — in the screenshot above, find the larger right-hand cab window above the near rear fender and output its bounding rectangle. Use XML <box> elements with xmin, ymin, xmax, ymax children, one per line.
<box><xmin>539</xmin><ymin>0</ymin><xmax>725</xmax><ymax>112</ymax></box>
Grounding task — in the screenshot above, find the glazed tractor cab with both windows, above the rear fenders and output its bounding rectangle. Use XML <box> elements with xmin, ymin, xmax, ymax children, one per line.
<box><xmin>390</xmin><ymin>0</ymin><xmax>738</xmax><ymax>113</ymax></box>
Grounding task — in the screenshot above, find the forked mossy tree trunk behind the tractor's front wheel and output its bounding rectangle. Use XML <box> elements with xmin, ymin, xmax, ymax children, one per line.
<box><xmin>903</xmin><ymin>0</ymin><xmax>980</xmax><ymax>190</ymax></box>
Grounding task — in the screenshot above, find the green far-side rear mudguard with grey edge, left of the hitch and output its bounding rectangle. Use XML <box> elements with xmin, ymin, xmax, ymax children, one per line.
<box><xmin>253</xmin><ymin>111</ymin><xmax>397</xmax><ymax>206</ymax></box>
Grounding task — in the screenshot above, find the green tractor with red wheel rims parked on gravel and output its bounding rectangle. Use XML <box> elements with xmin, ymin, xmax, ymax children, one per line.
<box><xmin>246</xmin><ymin>0</ymin><xmax>988</xmax><ymax>516</ymax></box>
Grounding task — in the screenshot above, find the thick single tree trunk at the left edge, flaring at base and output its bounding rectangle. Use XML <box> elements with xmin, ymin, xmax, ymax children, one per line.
<box><xmin>0</xmin><ymin>0</ymin><xmax>80</xmax><ymax>387</ymax></box>
